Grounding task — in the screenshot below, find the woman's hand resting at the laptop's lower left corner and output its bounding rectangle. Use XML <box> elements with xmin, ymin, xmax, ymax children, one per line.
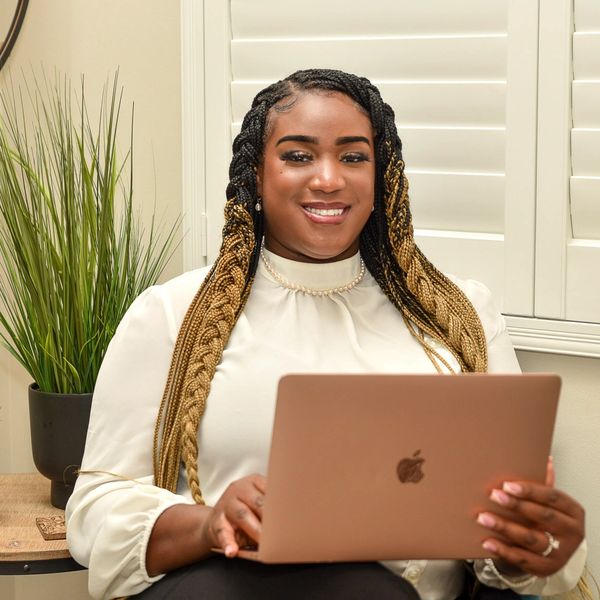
<box><xmin>203</xmin><ymin>475</ymin><xmax>267</xmax><ymax>558</ymax></box>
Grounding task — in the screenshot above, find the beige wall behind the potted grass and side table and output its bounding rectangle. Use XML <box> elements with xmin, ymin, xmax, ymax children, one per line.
<box><xmin>0</xmin><ymin>0</ymin><xmax>182</xmax><ymax>600</ymax></box>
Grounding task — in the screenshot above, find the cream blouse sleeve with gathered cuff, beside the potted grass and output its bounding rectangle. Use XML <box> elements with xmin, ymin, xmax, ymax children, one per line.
<box><xmin>66</xmin><ymin>272</ymin><xmax>205</xmax><ymax>598</ymax></box>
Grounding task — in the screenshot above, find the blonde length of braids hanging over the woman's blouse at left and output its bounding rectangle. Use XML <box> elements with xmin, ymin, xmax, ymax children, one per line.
<box><xmin>154</xmin><ymin>200</ymin><xmax>256</xmax><ymax>504</ymax></box>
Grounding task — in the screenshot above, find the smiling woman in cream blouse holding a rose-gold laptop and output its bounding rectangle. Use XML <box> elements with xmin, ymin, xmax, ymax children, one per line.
<box><xmin>67</xmin><ymin>70</ymin><xmax>586</xmax><ymax>600</ymax></box>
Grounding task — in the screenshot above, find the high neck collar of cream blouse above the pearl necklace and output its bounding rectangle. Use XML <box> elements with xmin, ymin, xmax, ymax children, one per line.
<box><xmin>259</xmin><ymin>248</ymin><xmax>361</xmax><ymax>290</ymax></box>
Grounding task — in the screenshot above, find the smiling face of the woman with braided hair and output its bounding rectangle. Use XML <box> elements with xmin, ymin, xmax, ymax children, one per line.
<box><xmin>257</xmin><ymin>92</ymin><xmax>375</xmax><ymax>262</ymax></box>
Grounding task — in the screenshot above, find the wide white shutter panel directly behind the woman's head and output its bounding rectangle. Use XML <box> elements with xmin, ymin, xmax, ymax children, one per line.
<box><xmin>225</xmin><ymin>0</ymin><xmax>537</xmax><ymax>315</ymax></box>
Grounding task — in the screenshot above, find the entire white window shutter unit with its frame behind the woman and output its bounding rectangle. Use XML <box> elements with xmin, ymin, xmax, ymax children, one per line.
<box><xmin>182</xmin><ymin>0</ymin><xmax>600</xmax><ymax>356</ymax></box>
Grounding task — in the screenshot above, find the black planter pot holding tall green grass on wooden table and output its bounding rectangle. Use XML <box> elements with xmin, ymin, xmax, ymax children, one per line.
<box><xmin>29</xmin><ymin>383</ymin><xmax>92</xmax><ymax>508</ymax></box>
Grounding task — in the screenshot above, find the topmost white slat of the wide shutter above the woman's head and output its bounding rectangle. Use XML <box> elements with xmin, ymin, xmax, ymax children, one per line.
<box><xmin>231</xmin><ymin>0</ymin><xmax>507</xmax><ymax>38</ymax></box>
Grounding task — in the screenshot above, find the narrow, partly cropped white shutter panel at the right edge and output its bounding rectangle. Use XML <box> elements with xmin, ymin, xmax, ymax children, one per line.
<box><xmin>535</xmin><ymin>0</ymin><xmax>600</xmax><ymax>323</ymax></box>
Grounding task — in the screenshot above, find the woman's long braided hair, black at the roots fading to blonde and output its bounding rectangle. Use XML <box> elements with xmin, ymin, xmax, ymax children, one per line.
<box><xmin>154</xmin><ymin>69</ymin><xmax>487</xmax><ymax>504</ymax></box>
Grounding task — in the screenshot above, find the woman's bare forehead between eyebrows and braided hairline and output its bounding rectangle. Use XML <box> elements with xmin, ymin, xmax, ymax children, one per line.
<box><xmin>266</xmin><ymin>91</ymin><xmax>373</xmax><ymax>143</ymax></box>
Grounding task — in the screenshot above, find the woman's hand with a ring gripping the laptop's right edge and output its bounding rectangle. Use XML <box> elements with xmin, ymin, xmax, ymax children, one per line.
<box><xmin>477</xmin><ymin>458</ymin><xmax>585</xmax><ymax>577</ymax></box>
